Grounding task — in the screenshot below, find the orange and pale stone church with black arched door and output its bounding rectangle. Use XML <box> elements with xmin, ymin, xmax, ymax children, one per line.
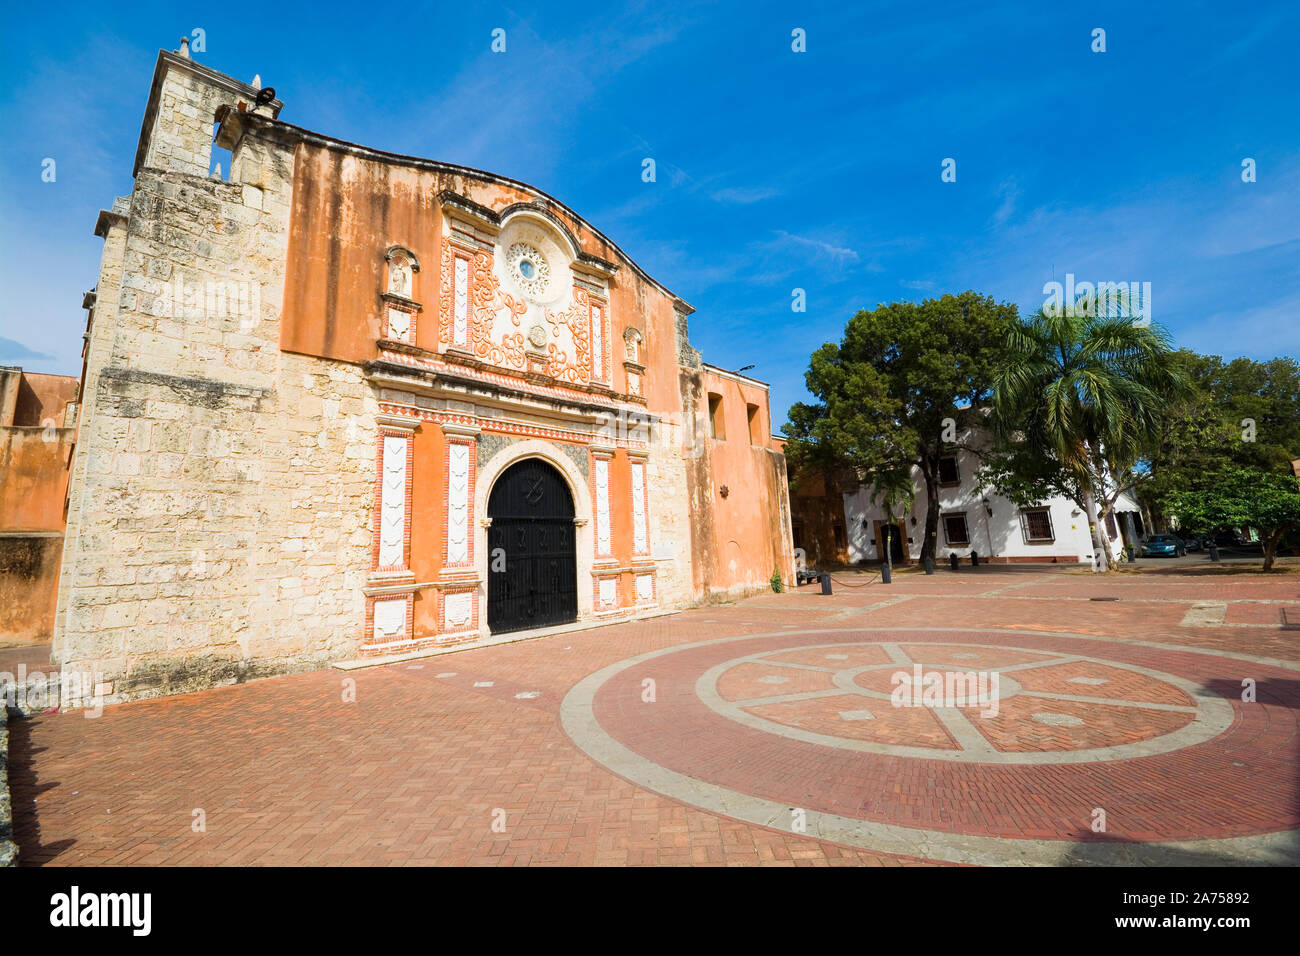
<box><xmin>53</xmin><ymin>46</ymin><xmax>793</xmax><ymax>700</ymax></box>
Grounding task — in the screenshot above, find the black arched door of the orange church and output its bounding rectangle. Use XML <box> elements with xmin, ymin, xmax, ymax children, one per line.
<box><xmin>488</xmin><ymin>458</ymin><xmax>577</xmax><ymax>633</ymax></box>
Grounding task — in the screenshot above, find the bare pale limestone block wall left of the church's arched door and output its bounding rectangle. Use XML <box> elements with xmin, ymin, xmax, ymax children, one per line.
<box><xmin>53</xmin><ymin>117</ymin><xmax>377</xmax><ymax>700</ymax></box>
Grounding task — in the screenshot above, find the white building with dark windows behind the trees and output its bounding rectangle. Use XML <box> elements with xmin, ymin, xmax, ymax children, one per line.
<box><xmin>844</xmin><ymin>450</ymin><xmax>1140</xmax><ymax>564</ymax></box>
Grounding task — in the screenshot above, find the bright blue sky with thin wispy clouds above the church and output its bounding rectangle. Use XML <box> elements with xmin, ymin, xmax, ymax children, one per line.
<box><xmin>0</xmin><ymin>0</ymin><xmax>1300</xmax><ymax>425</ymax></box>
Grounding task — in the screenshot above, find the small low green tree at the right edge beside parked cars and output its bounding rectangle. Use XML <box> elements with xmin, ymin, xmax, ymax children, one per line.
<box><xmin>1164</xmin><ymin>468</ymin><xmax>1300</xmax><ymax>571</ymax></box>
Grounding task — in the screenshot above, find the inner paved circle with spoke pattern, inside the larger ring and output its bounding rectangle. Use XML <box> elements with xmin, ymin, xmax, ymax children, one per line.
<box><xmin>696</xmin><ymin>641</ymin><xmax>1232</xmax><ymax>763</ymax></box>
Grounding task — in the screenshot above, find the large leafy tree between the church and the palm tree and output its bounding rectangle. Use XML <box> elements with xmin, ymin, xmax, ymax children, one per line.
<box><xmin>781</xmin><ymin>291</ymin><xmax>1018</xmax><ymax>559</ymax></box>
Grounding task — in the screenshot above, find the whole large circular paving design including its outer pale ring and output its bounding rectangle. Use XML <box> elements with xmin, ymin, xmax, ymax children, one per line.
<box><xmin>562</xmin><ymin>628</ymin><xmax>1300</xmax><ymax>864</ymax></box>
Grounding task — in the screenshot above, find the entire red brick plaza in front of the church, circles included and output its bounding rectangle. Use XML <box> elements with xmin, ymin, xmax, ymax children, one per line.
<box><xmin>10</xmin><ymin>567</ymin><xmax>1300</xmax><ymax>866</ymax></box>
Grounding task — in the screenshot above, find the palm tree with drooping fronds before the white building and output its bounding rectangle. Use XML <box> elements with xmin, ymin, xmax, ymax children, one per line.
<box><xmin>992</xmin><ymin>300</ymin><xmax>1186</xmax><ymax>571</ymax></box>
